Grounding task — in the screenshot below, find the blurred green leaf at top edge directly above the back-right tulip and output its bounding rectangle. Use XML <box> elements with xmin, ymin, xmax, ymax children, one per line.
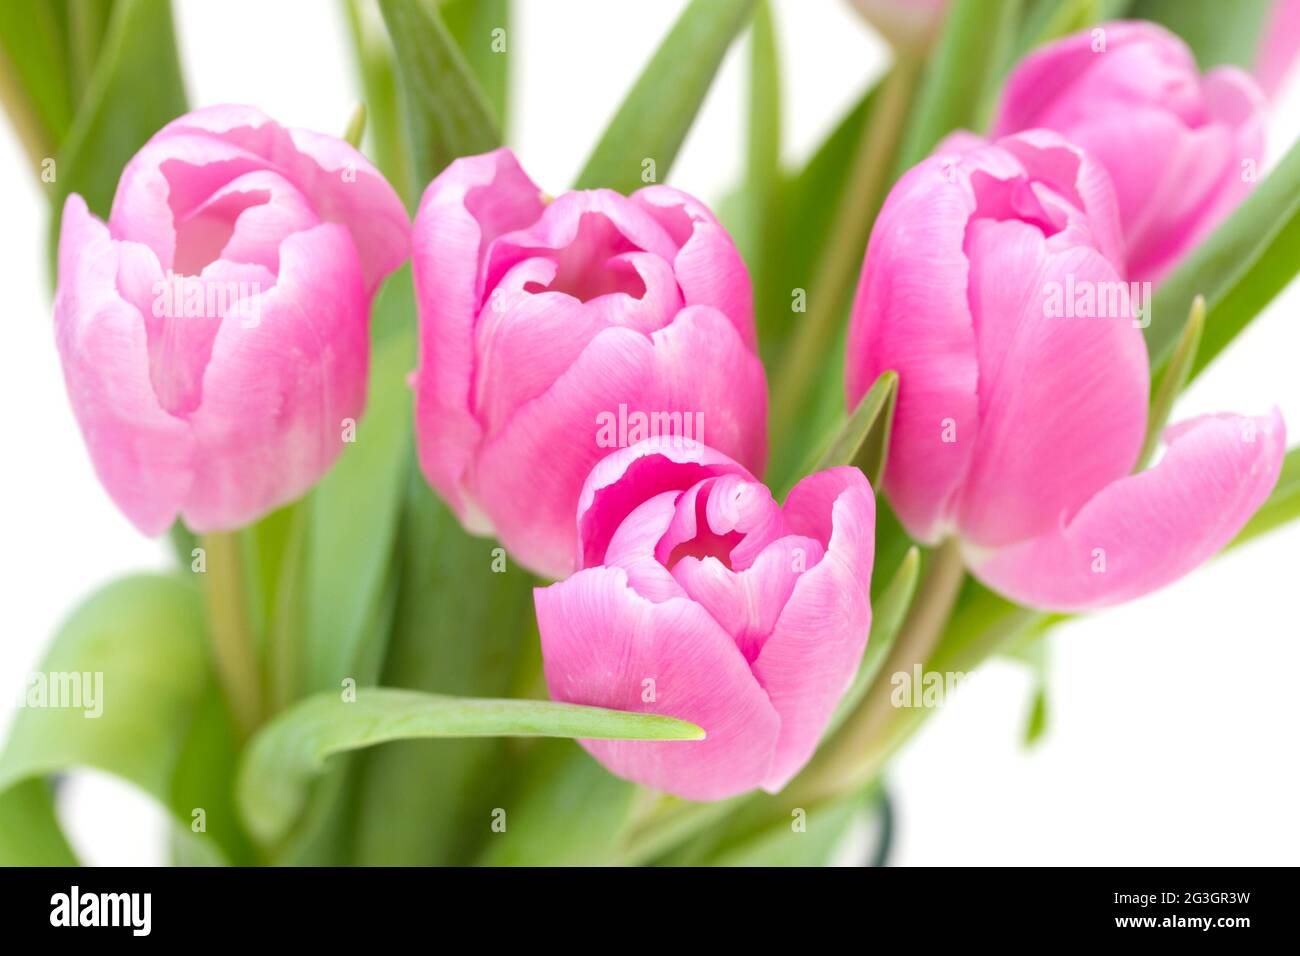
<box><xmin>1130</xmin><ymin>0</ymin><xmax>1274</xmax><ymax>70</ymax></box>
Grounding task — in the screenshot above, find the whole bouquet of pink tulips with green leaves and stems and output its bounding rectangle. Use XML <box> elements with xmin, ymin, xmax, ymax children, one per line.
<box><xmin>0</xmin><ymin>0</ymin><xmax>1300</xmax><ymax>865</ymax></box>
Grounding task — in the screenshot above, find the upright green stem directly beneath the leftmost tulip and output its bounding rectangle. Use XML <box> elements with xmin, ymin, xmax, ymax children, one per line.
<box><xmin>200</xmin><ymin>532</ymin><xmax>261</xmax><ymax>736</ymax></box>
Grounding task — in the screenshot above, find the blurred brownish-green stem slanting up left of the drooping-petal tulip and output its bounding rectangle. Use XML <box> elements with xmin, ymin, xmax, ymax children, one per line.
<box><xmin>770</xmin><ymin>59</ymin><xmax>919</xmax><ymax>447</ymax></box>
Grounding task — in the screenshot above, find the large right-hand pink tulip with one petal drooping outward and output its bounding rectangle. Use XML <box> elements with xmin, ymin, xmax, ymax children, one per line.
<box><xmin>846</xmin><ymin>130</ymin><xmax>1286</xmax><ymax>610</ymax></box>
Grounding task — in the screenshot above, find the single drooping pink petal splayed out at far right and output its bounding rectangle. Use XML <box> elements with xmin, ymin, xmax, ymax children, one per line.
<box><xmin>969</xmin><ymin>410</ymin><xmax>1286</xmax><ymax>611</ymax></box>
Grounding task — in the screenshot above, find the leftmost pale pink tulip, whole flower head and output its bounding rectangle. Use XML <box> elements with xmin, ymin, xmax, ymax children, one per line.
<box><xmin>55</xmin><ymin>107</ymin><xmax>410</xmax><ymax>535</ymax></box>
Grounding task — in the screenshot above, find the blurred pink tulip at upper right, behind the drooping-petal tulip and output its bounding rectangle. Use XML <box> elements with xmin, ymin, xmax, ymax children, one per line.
<box><xmin>995</xmin><ymin>22</ymin><xmax>1264</xmax><ymax>282</ymax></box>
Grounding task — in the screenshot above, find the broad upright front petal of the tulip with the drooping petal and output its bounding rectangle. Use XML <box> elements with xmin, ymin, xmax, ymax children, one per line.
<box><xmin>956</xmin><ymin>220</ymin><xmax>1149</xmax><ymax>545</ymax></box>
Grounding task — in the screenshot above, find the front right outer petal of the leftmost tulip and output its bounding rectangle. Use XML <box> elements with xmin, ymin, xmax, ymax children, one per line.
<box><xmin>183</xmin><ymin>224</ymin><xmax>369</xmax><ymax>532</ymax></box>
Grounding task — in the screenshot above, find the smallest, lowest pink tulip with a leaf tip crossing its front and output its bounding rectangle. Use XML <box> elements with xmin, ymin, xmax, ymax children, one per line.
<box><xmin>534</xmin><ymin>438</ymin><xmax>875</xmax><ymax>800</ymax></box>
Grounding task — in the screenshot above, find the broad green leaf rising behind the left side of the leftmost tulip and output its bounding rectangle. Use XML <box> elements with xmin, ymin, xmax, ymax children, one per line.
<box><xmin>49</xmin><ymin>0</ymin><xmax>186</xmax><ymax>274</ymax></box>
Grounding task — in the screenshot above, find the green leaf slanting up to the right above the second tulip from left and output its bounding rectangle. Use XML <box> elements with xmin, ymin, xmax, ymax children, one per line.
<box><xmin>576</xmin><ymin>0</ymin><xmax>754</xmax><ymax>193</ymax></box>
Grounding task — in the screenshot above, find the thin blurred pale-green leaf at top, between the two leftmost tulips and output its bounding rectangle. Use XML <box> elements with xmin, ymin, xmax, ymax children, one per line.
<box><xmin>343</xmin><ymin>0</ymin><xmax>410</xmax><ymax>209</ymax></box>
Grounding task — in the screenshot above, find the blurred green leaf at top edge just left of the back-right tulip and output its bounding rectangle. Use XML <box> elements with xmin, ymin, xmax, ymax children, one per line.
<box><xmin>894</xmin><ymin>0</ymin><xmax>1019</xmax><ymax>176</ymax></box>
